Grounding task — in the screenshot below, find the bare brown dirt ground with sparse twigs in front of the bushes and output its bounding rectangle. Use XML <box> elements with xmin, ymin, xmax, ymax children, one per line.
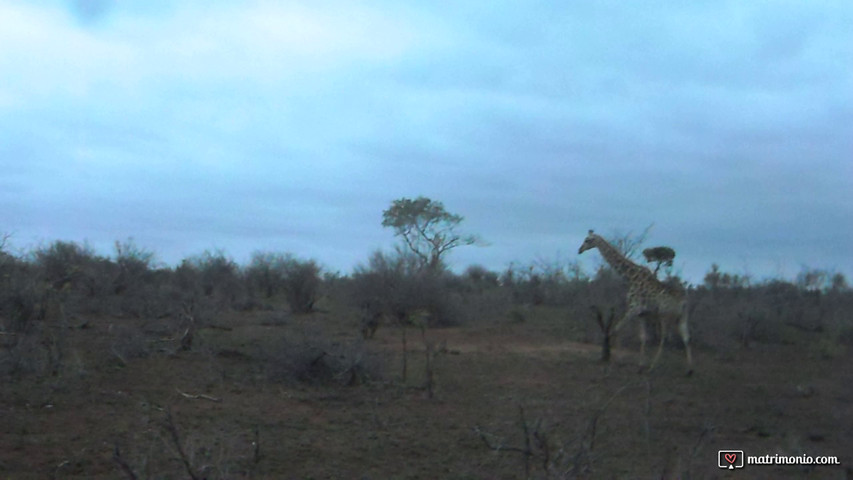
<box><xmin>0</xmin><ymin>311</ymin><xmax>853</xmax><ymax>479</ymax></box>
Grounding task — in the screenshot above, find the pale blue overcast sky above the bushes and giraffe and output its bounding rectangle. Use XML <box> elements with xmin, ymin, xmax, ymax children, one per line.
<box><xmin>0</xmin><ymin>0</ymin><xmax>853</xmax><ymax>281</ymax></box>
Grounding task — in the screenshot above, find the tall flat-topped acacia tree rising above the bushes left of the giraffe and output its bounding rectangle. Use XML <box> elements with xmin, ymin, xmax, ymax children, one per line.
<box><xmin>382</xmin><ymin>197</ymin><xmax>478</xmax><ymax>272</ymax></box>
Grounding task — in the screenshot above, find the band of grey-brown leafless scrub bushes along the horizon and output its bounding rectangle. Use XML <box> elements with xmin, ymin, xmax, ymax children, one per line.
<box><xmin>0</xmin><ymin>236</ymin><xmax>853</xmax><ymax>378</ymax></box>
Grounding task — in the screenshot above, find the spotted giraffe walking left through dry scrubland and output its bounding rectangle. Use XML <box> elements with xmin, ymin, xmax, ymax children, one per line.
<box><xmin>578</xmin><ymin>230</ymin><xmax>693</xmax><ymax>375</ymax></box>
